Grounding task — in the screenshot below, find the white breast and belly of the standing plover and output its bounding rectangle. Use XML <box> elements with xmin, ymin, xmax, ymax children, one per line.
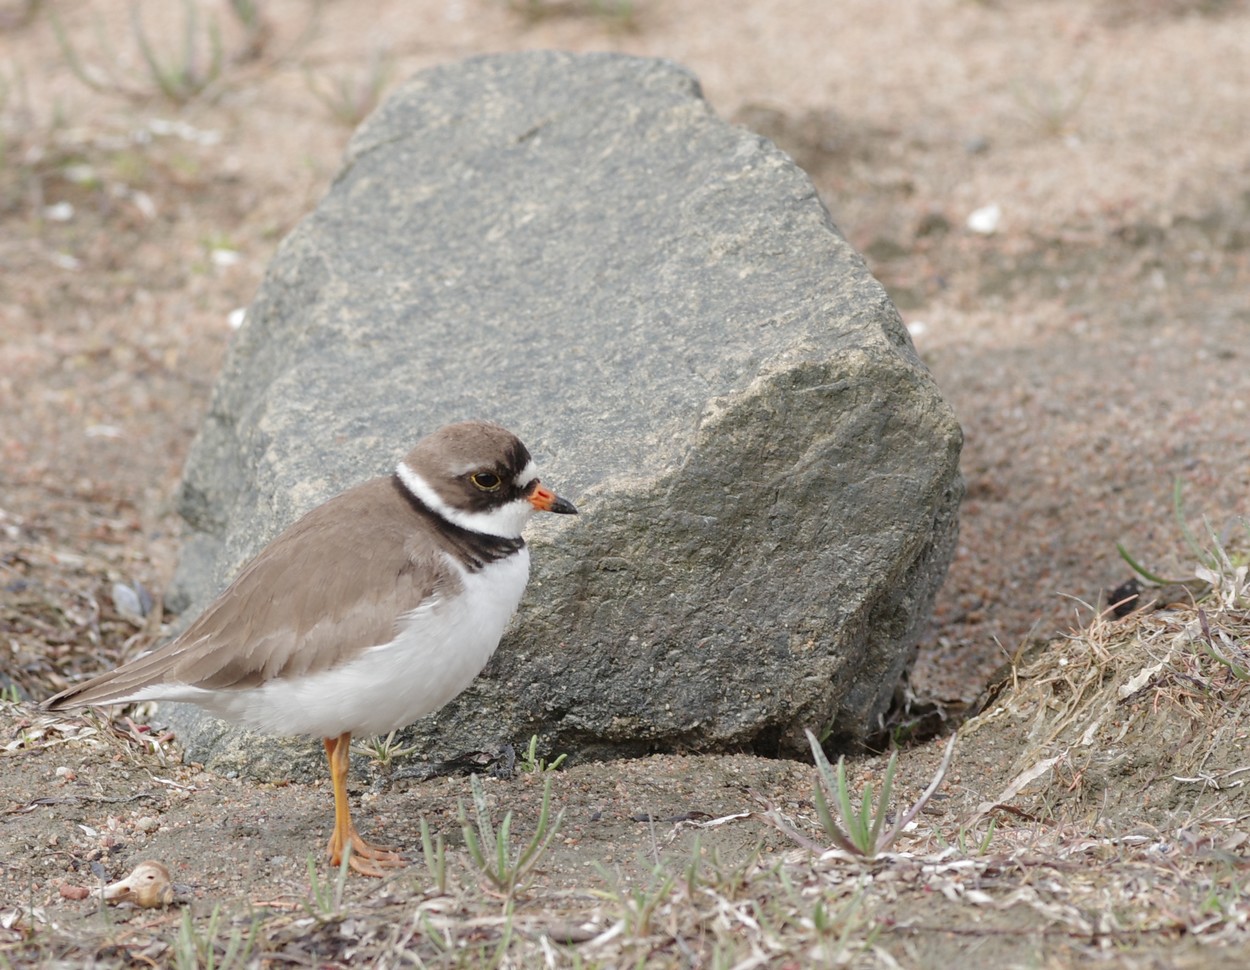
<box><xmin>183</xmin><ymin>548</ymin><xmax>530</xmax><ymax>738</ymax></box>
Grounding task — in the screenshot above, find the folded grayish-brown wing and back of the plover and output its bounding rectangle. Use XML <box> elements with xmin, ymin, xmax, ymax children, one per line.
<box><xmin>46</xmin><ymin>479</ymin><xmax>459</xmax><ymax>709</ymax></box>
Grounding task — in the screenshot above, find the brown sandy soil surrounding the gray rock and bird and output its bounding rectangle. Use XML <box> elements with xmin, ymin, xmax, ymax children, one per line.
<box><xmin>0</xmin><ymin>0</ymin><xmax>1250</xmax><ymax>966</ymax></box>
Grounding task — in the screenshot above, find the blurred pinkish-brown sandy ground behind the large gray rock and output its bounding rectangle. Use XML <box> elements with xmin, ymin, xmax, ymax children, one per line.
<box><xmin>0</xmin><ymin>0</ymin><xmax>1250</xmax><ymax>965</ymax></box>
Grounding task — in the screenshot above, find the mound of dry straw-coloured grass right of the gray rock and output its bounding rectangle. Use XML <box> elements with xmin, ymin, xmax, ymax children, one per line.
<box><xmin>961</xmin><ymin>569</ymin><xmax>1250</xmax><ymax>830</ymax></box>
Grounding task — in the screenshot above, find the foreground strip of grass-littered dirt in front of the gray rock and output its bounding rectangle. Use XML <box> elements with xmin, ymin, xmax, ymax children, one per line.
<box><xmin>7</xmin><ymin>590</ymin><xmax>1250</xmax><ymax>966</ymax></box>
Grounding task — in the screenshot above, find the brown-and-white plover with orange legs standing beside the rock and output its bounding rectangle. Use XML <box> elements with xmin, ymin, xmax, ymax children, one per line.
<box><xmin>44</xmin><ymin>420</ymin><xmax>578</xmax><ymax>876</ymax></box>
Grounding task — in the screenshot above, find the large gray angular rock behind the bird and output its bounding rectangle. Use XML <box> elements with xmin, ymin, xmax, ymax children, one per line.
<box><xmin>166</xmin><ymin>53</ymin><xmax>961</xmax><ymax>773</ymax></box>
